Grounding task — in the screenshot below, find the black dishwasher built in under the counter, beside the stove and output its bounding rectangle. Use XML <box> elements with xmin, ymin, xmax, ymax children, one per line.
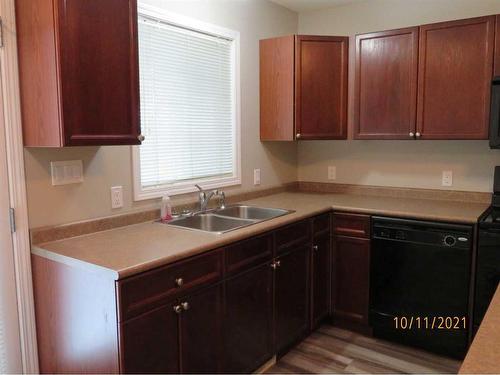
<box><xmin>370</xmin><ymin>217</ymin><xmax>472</xmax><ymax>358</ymax></box>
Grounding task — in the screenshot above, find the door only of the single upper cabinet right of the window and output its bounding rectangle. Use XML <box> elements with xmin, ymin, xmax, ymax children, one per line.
<box><xmin>295</xmin><ymin>35</ymin><xmax>349</xmax><ymax>139</ymax></box>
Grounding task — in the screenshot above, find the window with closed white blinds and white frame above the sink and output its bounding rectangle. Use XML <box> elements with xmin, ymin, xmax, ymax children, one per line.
<box><xmin>133</xmin><ymin>6</ymin><xmax>241</xmax><ymax>200</ymax></box>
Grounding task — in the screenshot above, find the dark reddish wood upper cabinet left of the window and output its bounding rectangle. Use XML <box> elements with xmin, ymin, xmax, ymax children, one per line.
<box><xmin>16</xmin><ymin>0</ymin><xmax>140</xmax><ymax>147</ymax></box>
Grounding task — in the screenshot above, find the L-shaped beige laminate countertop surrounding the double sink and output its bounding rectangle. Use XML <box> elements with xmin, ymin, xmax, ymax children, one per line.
<box><xmin>32</xmin><ymin>192</ymin><xmax>487</xmax><ymax>280</ymax></box>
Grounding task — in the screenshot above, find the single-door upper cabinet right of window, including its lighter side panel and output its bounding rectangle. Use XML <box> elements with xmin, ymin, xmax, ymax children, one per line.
<box><xmin>260</xmin><ymin>35</ymin><xmax>349</xmax><ymax>141</ymax></box>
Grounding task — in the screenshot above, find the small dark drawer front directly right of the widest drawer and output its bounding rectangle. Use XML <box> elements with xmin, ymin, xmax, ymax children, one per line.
<box><xmin>224</xmin><ymin>234</ymin><xmax>273</xmax><ymax>274</ymax></box>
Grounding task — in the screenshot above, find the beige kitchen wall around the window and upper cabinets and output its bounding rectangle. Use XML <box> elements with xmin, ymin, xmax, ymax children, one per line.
<box><xmin>25</xmin><ymin>0</ymin><xmax>500</xmax><ymax>228</ymax></box>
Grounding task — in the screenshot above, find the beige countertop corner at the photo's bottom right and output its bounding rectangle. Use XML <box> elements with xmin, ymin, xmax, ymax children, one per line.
<box><xmin>459</xmin><ymin>285</ymin><xmax>500</xmax><ymax>374</ymax></box>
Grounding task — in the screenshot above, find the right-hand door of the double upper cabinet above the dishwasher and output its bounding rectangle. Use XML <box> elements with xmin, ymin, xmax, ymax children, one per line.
<box><xmin>417</xmin><ymin>16</ymin><xmax>495</xmax><ymax>139</ymax></box>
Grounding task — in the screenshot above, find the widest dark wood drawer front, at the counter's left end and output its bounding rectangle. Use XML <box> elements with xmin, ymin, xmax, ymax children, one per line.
<box><xmin>117</xmin><ymin>250</ymin><xmax>223</xmax><ymax>320</ymax></box>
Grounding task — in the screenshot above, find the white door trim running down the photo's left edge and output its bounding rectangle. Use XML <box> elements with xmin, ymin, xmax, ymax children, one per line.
<box><xmin>0</xmin><ymin>0</ymin><xmax>38</xmax><ymax>373</ymax></box>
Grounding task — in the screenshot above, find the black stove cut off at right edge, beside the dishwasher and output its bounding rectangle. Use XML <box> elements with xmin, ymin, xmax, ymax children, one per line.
<box><xmin>473</xmin><ymin>167</ymin><xmax>500</xmax><ymax>330</ymax></box>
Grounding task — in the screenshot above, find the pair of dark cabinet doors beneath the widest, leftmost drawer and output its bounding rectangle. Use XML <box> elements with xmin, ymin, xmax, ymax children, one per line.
<box><xmin>121</xmin><ymin>284</ymin><xmax>222</xmax><ymax>373</ymax></box>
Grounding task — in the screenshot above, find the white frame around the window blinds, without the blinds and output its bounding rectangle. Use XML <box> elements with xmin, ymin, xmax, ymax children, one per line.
<box><xmin>131</xmin><ymin>4</ymin><xmax>241</xmax><ymax>201</ymax></box>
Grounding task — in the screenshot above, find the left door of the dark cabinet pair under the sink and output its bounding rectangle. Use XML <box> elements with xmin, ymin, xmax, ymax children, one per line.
<box><xmin>223</xmin><ymin>263</ymin><xmax>273</xmax><ymax>373</ymax></box>
